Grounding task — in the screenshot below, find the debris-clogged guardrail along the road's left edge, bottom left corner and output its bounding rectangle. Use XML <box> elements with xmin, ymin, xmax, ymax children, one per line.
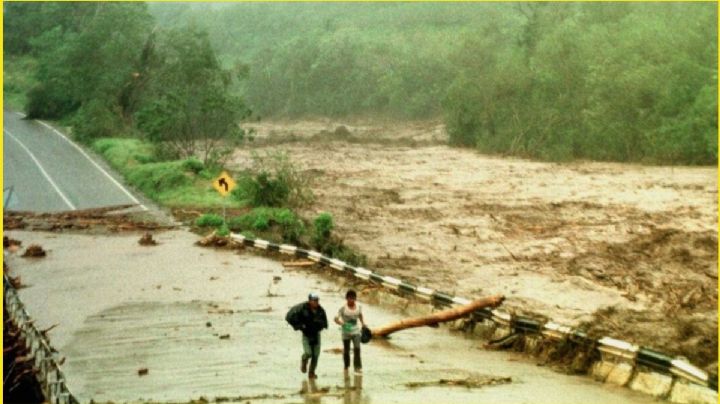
<box><xmin>3</xmin><ymin>274</ymin><xmax>78</xmax><ymax>404</ymax></box>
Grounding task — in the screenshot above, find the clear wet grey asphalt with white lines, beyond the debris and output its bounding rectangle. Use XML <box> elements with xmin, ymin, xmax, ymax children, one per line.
<box><xmin>3</xmin><ymin>109</ymin><xmax>144</xmax><ymax>212</ymax></box>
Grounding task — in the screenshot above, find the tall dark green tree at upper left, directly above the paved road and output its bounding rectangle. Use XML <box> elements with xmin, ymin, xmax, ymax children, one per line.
<box><xmin>27</xmin><ymin>3</ymin><xmax>152</xmax><ymax>133</ymax></box>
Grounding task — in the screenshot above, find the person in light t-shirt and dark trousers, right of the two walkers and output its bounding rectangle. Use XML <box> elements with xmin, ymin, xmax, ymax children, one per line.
<box><xmin>335</xmin><ymin>289</ymin><xmax>365</xmax><ymax>376</ymax></box>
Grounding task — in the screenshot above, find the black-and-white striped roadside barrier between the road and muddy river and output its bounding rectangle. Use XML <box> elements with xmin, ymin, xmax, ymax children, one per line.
<box><xmin>230</xmin><ymin>233</ymin><xmax>718</xmax><ymax>391</ymax></box>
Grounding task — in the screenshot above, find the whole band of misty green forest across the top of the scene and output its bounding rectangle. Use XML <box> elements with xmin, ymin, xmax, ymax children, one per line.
<box><xmin>4</xmin><ymin>3</ymin><xmax>717</xmax><ymax>164</ymax></box>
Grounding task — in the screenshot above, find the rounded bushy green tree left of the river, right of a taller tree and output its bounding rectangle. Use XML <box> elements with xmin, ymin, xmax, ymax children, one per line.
<box><xmin>135</xmin><ymin>26</ymin><xmax>250</xmax><ymax>165</ymax></box>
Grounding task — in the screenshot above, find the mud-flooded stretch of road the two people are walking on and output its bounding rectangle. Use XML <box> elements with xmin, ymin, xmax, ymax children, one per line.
<box><xmin>7</xmin><ymin>231</ymin><xmax>653</xmax><ymax>403</ymax></box>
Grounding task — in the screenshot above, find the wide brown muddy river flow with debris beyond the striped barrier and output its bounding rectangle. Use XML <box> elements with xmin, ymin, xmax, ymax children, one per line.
<box><xmin>234</xmin><ymin>121</ymin><xmax>718</xmax><ymax>370</ymax></box>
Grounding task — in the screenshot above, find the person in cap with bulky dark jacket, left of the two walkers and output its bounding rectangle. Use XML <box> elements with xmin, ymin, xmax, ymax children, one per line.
<box><xmin>285</xmin><ymin>293</ymin><xmax>328</xmax><ymax>379</ymax></box>
